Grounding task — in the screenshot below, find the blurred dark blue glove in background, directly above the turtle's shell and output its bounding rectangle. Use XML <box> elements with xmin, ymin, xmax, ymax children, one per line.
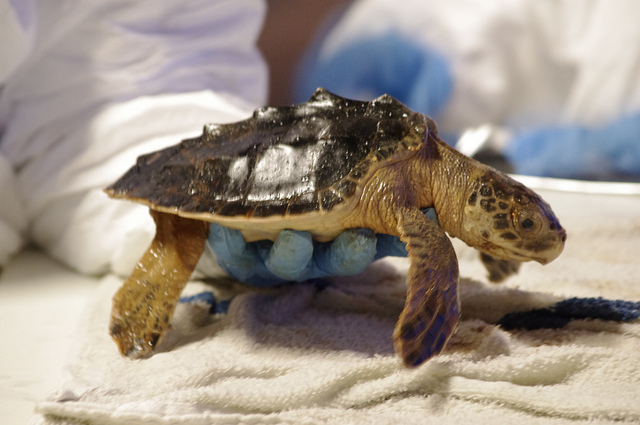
<box><xmin>294</xmin><ymin>32</ymin><xmax>453</xmax><ymax>116</ymax></box>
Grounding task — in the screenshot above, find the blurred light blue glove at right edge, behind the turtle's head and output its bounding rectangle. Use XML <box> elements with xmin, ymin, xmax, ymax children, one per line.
<box><xmin>505</xmin><ymin>112</ymin><xmax>640</xmax><ymax>179</ymax></box>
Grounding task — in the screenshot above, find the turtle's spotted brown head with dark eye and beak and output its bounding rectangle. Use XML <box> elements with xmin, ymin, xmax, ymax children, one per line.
<box><xmin>461</xmin><ymin>170</ymin><xmax>567</xmax><ymax>264</ymax></box>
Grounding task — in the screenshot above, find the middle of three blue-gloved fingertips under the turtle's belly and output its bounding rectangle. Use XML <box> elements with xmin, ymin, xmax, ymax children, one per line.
<box><xmin>258</xmin><ymin>229</ymin><xmax>314</xmax><ymax>281</ymax></box>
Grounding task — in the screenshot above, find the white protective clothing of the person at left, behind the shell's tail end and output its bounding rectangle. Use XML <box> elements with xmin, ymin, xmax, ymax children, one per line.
<box><xmin>0</xmin><ymin>0</ymin><xmax>267</xmax><ymax>273</ymax></box>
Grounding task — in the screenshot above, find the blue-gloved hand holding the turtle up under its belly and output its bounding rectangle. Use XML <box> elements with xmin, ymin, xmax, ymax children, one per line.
<box><xmin>207</xmin><ymin>208</ymin><xmax>438</xmax><ymax>287</ymax></box>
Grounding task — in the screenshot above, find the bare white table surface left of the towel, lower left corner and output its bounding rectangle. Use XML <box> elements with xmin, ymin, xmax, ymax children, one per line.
<box><xmin>0</xmin><ymin>250</ymin><xmax>98</xmax><ymax>425</ymax></box>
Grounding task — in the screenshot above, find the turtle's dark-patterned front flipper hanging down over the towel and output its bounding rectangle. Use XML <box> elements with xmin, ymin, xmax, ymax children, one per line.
<box><xmin>393</xmin><ymin>209</ymin><xmax>460</xmax><ymax>367</ymax></box>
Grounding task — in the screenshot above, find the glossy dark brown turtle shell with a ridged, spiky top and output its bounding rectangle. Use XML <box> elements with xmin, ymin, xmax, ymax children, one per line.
<box><xmin>106</xmin><ymin>89</ymin><xmax>430</xmax><ymax>217</ymax></box>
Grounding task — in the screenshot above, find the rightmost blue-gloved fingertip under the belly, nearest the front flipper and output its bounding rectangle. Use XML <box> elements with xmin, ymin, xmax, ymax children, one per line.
<box><xmin>313</xmin><ymin>229</ymin><xmax>376</xmax><ymax>277</ymax></box>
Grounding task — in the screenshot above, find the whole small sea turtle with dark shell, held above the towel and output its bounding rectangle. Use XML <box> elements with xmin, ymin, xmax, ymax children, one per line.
<box><xmin>105</xmin><ymin>89</ymin><xmax>566</xmax><ymax>366</ymax></box>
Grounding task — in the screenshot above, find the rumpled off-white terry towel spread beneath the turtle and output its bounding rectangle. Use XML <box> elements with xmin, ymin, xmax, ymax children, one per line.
<box><xmin>32</xmin><ymin>187</ymin><xmax>640</xmax><ymax>425</ymax></box>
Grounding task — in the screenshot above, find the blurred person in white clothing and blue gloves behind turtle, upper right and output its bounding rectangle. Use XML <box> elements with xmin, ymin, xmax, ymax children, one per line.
<box><xmin>293</xmin><ymin>0</ymin><xmax>640</xmax><ymax>181</ymax></box>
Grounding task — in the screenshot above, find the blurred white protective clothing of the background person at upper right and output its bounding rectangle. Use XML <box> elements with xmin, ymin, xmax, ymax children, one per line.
<box><xmin>319</xmin><ymin>0</ymin><xmax>640</xmax><ymax>133</ymax></box>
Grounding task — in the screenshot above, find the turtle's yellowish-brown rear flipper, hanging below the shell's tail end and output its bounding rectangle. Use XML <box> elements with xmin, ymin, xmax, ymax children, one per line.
<box><xmin>109</xmin><ymin>210</ymin><xmax>209</xmax><ymax>358</ymax></box>
